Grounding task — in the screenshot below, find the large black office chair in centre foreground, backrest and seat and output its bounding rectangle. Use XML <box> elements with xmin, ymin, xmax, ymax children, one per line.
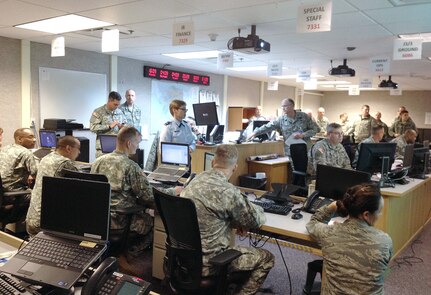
<box><xmin>153</xmin><ymin>188</ymin><xmax>246</xmax><ymax>295</ymax></box>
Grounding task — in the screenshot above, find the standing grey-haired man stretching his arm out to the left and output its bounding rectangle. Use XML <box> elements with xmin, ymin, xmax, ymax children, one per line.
<box><xmin>247</xmin><ymin>98</ymin><xmax>319</xmax><ymax>155</ymax></box>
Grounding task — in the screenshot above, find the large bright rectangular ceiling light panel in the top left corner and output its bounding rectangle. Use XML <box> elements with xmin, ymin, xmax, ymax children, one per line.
<box><xmin>15</xmin><ymin>14</ymin><xmax>113</xmax><ymax>34</ymax></box>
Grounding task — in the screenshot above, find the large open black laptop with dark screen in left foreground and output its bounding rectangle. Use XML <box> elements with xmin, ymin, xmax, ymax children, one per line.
<box><xmin>0</xmin><ymin>176</ymin><xmax>111</xmax><ymax>289</ymax></box>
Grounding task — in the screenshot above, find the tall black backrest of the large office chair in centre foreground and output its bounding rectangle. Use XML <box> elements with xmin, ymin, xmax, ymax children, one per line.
<box><xmin>153</xmin><ymin>188</ymin><xmax>202</xmax><ymax>291</ymax></box>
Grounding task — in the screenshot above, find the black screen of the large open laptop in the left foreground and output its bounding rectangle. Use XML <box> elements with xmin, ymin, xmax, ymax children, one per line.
<box><xmin>40</xmin><ymin>176</ymin><xmax>111</xmax><ymax>240</ymax></box>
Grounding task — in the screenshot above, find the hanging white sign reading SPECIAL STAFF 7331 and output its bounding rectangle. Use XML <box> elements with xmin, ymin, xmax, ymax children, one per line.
<box><xmin>296</xmin><ymin>1</ymin><xmax>332</xmax><ymax>33</ymax></box>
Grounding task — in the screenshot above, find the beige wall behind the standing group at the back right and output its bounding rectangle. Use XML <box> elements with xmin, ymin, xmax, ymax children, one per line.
<box><xmin>322</xmin><ymin>90</ymin><xmax>431</xmax><ymax>128</ymax></box>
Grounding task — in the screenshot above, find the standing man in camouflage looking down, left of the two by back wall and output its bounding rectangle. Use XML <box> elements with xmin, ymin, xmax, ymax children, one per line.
<box><xmin>90</xmin><ymin>91</ymin><xmax>126</xmax><ymax>157</ymax></box>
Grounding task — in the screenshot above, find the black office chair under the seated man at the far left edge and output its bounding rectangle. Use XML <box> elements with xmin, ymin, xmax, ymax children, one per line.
<box><xmin>0</xmin><ymin>176</ymin><xmax>31</xmax><ymax>231</ymax></box>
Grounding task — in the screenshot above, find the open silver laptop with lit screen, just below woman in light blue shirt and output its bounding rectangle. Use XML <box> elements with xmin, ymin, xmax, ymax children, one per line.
<box><xmin>147</xmin><ymin>142</ymin><xmax>190</xmax><ymax>182</ymax></box>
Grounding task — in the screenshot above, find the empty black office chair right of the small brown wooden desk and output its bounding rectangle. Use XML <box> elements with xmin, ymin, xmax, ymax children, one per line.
<box><xmin>289</xmin><ymin>143</ymin><xmax>309</xmax><ymax>187</ymax></box>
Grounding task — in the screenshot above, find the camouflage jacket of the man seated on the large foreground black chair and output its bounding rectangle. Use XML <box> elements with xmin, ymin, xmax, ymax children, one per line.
<box><xmin>181</xmin><ymin>169</ymin><xmax>266</xmax><ymax>276</ymax></box>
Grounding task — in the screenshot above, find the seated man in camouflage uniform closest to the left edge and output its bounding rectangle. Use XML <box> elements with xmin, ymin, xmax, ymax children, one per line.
<box><xmin>0</xmin><ymin>128</ymin><xmax>37</xmax><ymax>205</ymax></box>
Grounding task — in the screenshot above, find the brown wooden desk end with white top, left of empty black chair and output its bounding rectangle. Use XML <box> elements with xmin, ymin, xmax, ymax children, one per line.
<box><xmin>248</xmin><ymin>157</ymin><xmax>290</xmax><ymax>191</ymax></box>
